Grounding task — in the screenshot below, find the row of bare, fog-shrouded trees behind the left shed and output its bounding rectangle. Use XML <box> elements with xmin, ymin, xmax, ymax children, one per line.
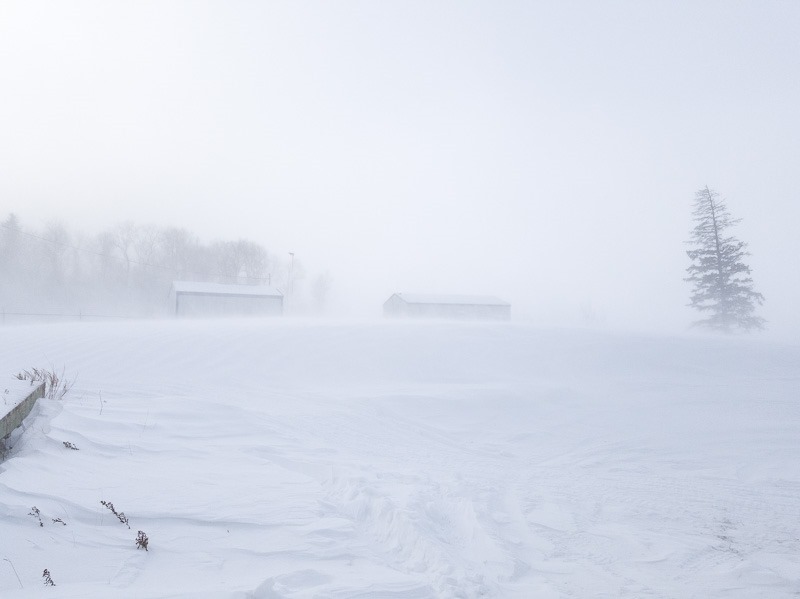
<box><xmin>0</xmin><ymin>214</ymin><xmax>318</xmax><ymax>316</ymax></box>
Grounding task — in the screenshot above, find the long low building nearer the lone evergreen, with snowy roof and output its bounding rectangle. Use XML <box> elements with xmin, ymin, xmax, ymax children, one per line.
<box><xmin>383</xmin><ymin>293</ymin><xmax>511</xmax><ymax>320</ymax></box>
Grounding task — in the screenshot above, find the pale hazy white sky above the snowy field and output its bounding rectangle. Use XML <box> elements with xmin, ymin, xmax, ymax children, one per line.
<box><xmin>0</xmin><ymin>0</ymin><xmax>800</xmax><ymax>338</ymax></box>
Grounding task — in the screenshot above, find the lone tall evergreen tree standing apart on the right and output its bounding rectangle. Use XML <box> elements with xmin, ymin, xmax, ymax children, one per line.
<box><xmin>685</xmin><ymin>186</ymin><xmax>765</xmax><ymax>333</ymax></box>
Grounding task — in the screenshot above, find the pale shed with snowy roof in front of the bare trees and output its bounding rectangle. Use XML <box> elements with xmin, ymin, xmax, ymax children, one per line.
<box><xmin>169</xmin><ymin>281</ymin><xmax>283</xmax><ymax>317</ymax></box>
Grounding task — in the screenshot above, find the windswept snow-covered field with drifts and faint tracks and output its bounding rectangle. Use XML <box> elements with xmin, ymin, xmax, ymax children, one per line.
<box><xmin>0</xmin><ymin>320</ymin><xmax>800</xmax><ymax>599</ymax></box>
